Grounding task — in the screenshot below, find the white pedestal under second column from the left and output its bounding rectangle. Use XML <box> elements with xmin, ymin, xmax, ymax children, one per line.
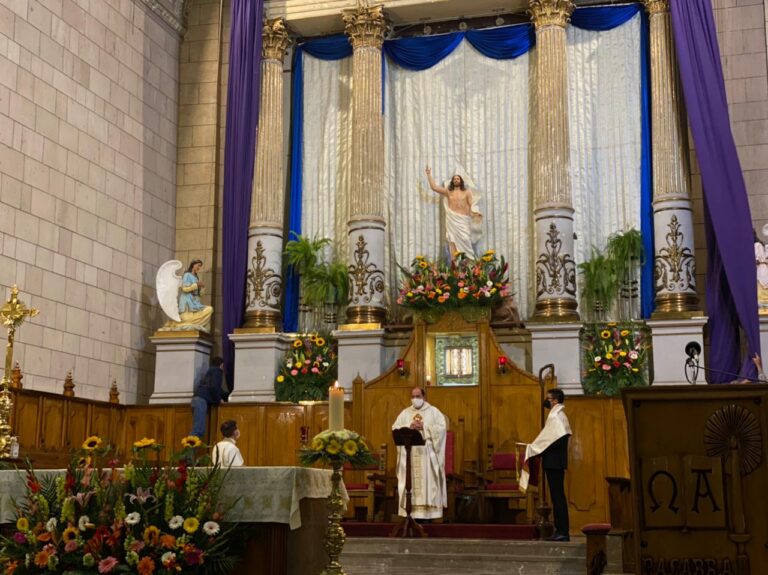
<box><xmin>333</xmin><ymin>329</ymin><xmax>388</xmax><ymax>392</ymax></box>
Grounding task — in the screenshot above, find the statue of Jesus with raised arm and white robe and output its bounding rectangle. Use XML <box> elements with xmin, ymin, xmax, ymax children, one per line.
<box><xmin>426</xmin><ymin>166</ymin><xmax>483</xmax><ymax>259</ymax></box>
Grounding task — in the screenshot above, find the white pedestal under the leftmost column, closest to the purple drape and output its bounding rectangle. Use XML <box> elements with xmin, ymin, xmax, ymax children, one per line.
<box><xmin>229</xmin><ymin>333</ymin><xmax>292</xmax><ymax>403</ymax></box>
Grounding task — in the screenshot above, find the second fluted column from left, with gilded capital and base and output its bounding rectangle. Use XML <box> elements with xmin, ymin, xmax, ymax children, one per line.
<box><xmin>343</xmin><ymin>3</ymin><xmax>387</xmax><ymax>324</ymax></box>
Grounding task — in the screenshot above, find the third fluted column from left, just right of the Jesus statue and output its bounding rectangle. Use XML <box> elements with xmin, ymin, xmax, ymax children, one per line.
<box><xmin>528</xmin><ymin>0</ymin><xmax>579</xmax><ymax>321</ymax></box>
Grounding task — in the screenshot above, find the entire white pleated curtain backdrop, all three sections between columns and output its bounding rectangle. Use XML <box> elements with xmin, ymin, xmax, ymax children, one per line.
<box><xmin>302</xmin><ymin>16</ymin><xmax>641</xmax><ymax>324</ymax></box>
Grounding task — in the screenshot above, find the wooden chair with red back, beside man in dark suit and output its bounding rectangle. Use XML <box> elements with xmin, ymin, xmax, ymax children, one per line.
<box><xmin>478</xmin><ymin>444</ymin><xmax>540</xmax><ymax>523</ymax></box>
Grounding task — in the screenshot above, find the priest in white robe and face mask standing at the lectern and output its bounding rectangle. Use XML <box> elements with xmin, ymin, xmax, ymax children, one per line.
<box><xmin>392</xmin><ymin>387</ymin><xmax>448</xmax><ymax>519</ymax></box>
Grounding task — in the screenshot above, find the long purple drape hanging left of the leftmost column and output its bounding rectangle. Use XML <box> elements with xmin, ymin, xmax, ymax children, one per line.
<box><xmin>221</xmin><ymin>0</ymin><xmax>263</xmax><ymax>389</ymax></box>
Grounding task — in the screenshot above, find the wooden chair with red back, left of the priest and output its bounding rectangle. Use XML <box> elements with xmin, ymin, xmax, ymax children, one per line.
<box><xmin>344</xmin><ymin>443</ymin><xmax>394</xmax><ymax>523</ymax></box>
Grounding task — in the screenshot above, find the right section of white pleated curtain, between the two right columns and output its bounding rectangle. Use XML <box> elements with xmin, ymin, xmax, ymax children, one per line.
<box><xmin>567</xmin><ymin>14</ymin><xmax>642</xmax><ymax>306</ymax></box>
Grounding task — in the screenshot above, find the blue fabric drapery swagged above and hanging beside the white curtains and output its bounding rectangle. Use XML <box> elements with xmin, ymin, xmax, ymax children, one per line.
<box><xmin>284</xmin><ymin>4</ymin><xmax>654</xmax><ymax>324</ymax></box>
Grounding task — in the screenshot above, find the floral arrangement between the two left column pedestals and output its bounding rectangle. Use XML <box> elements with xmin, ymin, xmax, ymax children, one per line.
<box><xmin>275</xmin><ymin>333</ymin><xmax>338</xmax><ymax>403</ymax></box>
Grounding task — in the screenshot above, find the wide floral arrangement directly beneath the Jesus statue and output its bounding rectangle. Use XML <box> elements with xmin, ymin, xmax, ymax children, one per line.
<box><xmin>397</xmin><ymin>250</ymin><xmax>509</xmax><ymax>310</ymax></box>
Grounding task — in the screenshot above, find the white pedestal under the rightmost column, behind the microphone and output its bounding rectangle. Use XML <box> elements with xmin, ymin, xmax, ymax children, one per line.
<box><xmin>646</xmin><ymin>316</ymin><xmax>708</xmax><ymax>385</ymax></box>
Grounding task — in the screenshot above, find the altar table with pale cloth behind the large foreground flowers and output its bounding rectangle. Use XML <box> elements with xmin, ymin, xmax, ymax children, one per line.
<box><xmin>0</xmin><ymin>467</ymin><xmax>348</xmax><ymax>575</ymax></box>
